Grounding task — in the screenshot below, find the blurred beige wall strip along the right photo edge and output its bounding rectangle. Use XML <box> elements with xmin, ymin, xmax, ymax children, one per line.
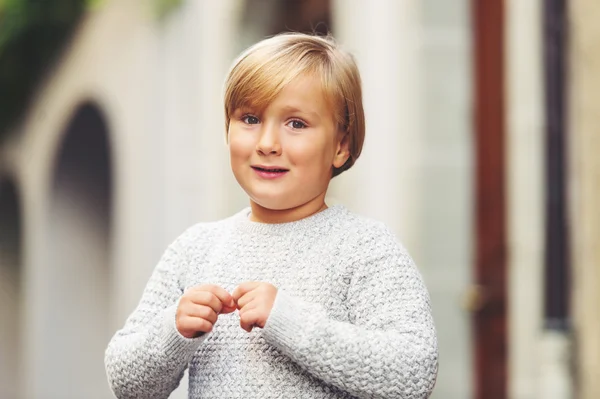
<box><xmin>569</xmin><ymin>0</ymin><xmax>600</xmax><ymax>399</ymax></box>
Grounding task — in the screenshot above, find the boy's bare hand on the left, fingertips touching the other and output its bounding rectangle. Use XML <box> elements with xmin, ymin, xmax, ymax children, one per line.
<box><xmin>175</xmin><ymin>285</ymin><xmax>236</xmax><ymax>338</ymax></box>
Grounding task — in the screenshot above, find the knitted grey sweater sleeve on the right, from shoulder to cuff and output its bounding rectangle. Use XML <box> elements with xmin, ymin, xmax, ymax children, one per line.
<box><xmin>263</xmin><ymin>228</ymin><xmax>438</xmax><ymax>399</ymax></box>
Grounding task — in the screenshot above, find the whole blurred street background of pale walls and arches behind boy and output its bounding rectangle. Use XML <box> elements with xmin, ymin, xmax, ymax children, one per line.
<box><xmin>0</xmin><ymin>0</ymin><xmax>600</xmax><ymax>399</ymax></box>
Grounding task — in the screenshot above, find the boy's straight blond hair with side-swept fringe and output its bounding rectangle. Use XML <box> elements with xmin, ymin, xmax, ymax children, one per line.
<box><xmin>225</xmin><ymin>33</ymin><xmax>365</xmax><ymax>177</ymax></box>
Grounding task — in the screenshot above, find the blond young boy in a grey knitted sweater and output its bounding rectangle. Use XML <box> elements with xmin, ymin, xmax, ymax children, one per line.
<box><xmin>105</xmin><ymin>34</ymin><xmax>438</xmax><ymax>398</ymax></box>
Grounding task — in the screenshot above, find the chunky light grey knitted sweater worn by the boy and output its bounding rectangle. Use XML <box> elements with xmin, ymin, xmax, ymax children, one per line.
<box><xmin>105</xmin><ymin>205</ymin><xmax>438</xmax><ymax>399</ymax></box>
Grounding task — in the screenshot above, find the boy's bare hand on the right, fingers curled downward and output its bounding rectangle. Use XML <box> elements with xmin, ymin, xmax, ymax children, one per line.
<box><xmin>231</xmin><ymin>282</ymin><xmax>277</xmax><ymax>332</ymax></box>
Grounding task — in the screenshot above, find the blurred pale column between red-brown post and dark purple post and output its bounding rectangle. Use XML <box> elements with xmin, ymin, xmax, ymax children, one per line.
<box><xmin>506</xmin><ymin>0</ymin><xmax>547</xmax><ymax>399</ymax></box>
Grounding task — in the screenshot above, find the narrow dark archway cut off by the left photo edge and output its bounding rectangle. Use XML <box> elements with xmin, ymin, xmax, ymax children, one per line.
<box><xmin>0</xmin><ymin>179</ymin><xmax>22</xmax><ymax>398</ymax></box>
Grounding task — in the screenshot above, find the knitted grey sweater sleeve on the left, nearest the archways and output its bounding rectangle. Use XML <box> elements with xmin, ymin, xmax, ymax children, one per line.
<box><xmin>104</xmin><ymin>233</ymin><xmax>206</xmax><ymax>399</ymax></box>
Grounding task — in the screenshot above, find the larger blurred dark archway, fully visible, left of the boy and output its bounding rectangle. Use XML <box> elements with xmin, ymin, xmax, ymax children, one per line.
<box><xmin>42</xmin><ymin>104</ymin><xmax>113</xmax><ymax>398</ymax></box>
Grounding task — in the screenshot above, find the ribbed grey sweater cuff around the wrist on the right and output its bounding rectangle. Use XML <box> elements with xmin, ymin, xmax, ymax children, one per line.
<box><xmin>262</xmin><ymin>290</ymin><xmax>306</xmax><ymax>353</ymax></box>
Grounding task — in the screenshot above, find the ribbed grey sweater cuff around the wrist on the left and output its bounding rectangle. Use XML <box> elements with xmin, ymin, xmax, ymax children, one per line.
<box><xmin>158</xmin><ymin>305</ymin><xmax>207</xmax><ymax>359</ymax></box>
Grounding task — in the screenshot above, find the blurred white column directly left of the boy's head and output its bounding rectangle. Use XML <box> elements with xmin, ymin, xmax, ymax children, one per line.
<box><xmin>160</xmin><ymin>1</ymin><xmax>247</xmax><ymax>240</ymax></box>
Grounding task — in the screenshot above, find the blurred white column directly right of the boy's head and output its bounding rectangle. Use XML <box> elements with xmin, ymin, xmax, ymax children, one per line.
<box><xmin>330</xmin><ymin>0</ymin><xmax>421</xmax><ymax>248</ymax></box>
